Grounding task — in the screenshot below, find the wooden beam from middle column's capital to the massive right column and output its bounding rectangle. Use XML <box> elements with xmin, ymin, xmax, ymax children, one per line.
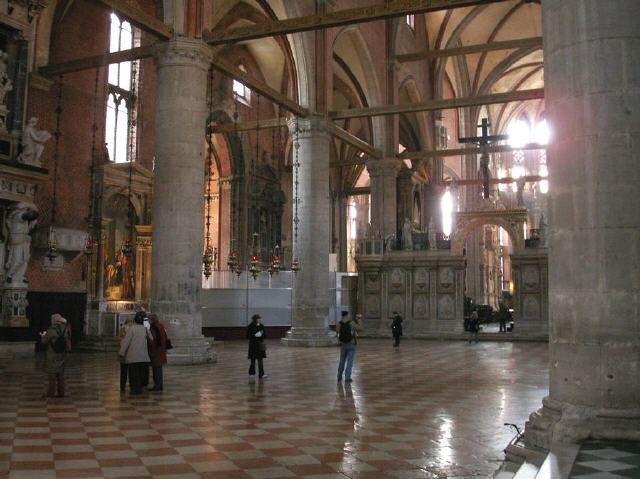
<box><xmin>329</xmin><ymin>88</ymin><xmax>544</xmax><ymax>120</ymax></box>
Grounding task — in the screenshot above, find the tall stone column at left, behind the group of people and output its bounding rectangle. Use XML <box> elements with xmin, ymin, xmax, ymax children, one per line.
<box><xmin>150</xmin><ymin>38</ymin><xmax>213</xmax><ymax>364</ymax></box>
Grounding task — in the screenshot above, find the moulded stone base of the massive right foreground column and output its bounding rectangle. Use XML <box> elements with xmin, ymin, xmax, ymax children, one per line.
<box><xmin>524</xmin><ymin>397</ymin><xmax>640</xmax><ymax>450</ymax></box>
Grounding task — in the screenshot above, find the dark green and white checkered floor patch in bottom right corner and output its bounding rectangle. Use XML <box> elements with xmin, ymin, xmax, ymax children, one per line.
<box><xmin>570</xmin><ymin>441</ymin><xmax>640</xmax><ymax>479</ymax></box>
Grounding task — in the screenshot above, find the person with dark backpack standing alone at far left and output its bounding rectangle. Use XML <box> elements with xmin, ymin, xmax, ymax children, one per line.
<box><xmin>40</xmin><ymin>313</ymin><xmax>71</xmax><ymax>398</ymax></box>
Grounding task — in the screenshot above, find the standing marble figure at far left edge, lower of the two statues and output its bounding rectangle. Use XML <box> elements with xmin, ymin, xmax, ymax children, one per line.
<box><xmin>5</xmin><ymin>203</ymin><xmax>38</xmax><ymax>288</ymax></box>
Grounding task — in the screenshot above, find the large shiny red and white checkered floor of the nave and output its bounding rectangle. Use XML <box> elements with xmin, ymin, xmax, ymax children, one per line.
<box><xmin>0</xmin><ymin>339</ymin><xmax>547</xmax><ymax>479</ymax></box>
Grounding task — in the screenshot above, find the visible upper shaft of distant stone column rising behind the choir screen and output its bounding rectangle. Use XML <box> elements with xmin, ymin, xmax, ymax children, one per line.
<box><xmin>367</xmin><ymin>158</ymin><xmax>404</xmax><ymax>238</ymax></box>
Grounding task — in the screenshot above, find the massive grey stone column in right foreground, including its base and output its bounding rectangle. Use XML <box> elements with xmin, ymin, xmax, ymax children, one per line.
<box><xmin>525</xmin><ymin>0</ymin><xmax>640</xmax><ymax>448</ymax></box>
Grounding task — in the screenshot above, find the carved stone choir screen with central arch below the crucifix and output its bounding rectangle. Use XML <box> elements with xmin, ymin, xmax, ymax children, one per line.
<box><xmin>355</xmin><ymin>208</ymin><xmax>549</xmax><ymax>340</ymax></box>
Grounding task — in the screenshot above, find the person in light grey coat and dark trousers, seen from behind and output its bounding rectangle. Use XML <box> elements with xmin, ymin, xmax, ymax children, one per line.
<box><xmin>118</xmin><ymin>312</ymin><xmax>153</xmax><ymax>395</ymax></box>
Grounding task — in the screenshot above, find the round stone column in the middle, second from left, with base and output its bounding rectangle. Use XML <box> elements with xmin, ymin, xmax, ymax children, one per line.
<box><xmin>283</xmin><ymin>115</ymin><xmax>336</xmax><ymax>346</ymax></box>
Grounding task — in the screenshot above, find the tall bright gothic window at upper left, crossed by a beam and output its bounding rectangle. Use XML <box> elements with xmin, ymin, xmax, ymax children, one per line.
<box><xmin>105</xmin><ymin>13</ymin><xmax>140</xmax><ymax>163</ymax></box>
